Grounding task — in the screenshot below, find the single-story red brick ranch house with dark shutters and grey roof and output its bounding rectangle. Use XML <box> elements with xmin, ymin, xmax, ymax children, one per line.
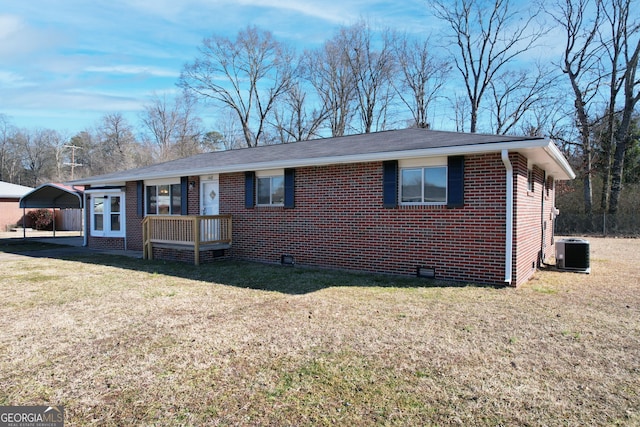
<box><xmin>72</xmin><ymin>129</ymin><xmax>575</xmax><ymax>286</ymax></box>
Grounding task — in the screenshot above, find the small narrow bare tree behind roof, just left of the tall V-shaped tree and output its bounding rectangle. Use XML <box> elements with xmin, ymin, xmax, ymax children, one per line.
<box><xmin>395</xmin><ymin>35</ymin><xmax>451</xmax><ymax>128</ymax></box>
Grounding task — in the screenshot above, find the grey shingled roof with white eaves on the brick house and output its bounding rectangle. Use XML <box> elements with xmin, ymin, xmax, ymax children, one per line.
<box><xmin>70</xmin><ymin>128</ymin><xmax>575</xmax><ymax>186</ymax></box>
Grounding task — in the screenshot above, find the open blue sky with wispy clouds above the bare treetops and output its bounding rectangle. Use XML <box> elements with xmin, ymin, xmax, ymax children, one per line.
<box><xmin>0</xmin><ymin>0</ymin><xmax>433</xmax><ymax>136</ymax></box>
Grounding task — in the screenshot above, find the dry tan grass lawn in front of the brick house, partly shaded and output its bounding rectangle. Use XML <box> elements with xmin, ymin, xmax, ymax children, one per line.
<box><xmin>0</xmin><ymin>239</ymin><xmax>640</xmax><ymax>425</ymax></box>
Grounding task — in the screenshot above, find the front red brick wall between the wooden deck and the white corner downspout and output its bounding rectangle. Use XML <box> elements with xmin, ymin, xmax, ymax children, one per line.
<box><xmin>220</xmin><ymin>154</ymin><xmax>526</xmax><ymax>283</ymax></box>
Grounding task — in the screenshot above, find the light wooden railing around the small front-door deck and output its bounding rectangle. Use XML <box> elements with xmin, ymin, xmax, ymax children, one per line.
<box><xmin>142</xmin><ymin>215</ymin><xmax>232</xmax><ymax>265</ymax></box>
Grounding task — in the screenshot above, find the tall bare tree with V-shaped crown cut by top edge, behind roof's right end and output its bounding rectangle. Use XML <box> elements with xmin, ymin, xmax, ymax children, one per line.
<box><xmin>432</xmin><ymin>0</ymin><xmax>541</xmax><ymax>132</ymax></box>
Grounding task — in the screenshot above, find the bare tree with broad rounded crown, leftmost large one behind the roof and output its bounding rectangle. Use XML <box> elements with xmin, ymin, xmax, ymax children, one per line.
<box><xmin>178</xmin><ymin>27</ymin><xmax>294</xmax><ymax>147</ymax></box>
